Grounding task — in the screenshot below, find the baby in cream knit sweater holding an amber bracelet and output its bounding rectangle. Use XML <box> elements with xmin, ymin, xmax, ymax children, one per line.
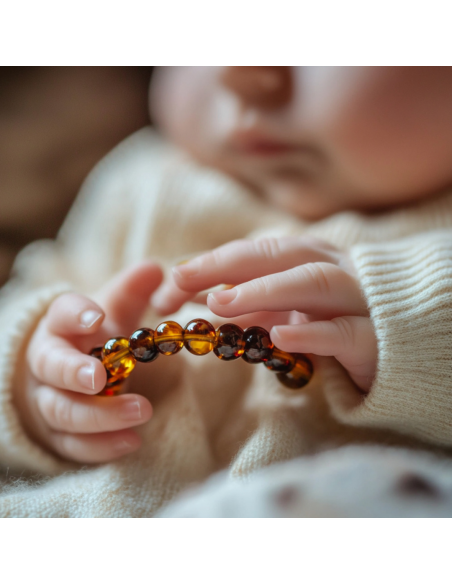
<box><xmin>0</xmin><ymin>67</ymin><xmax>452</xmax><ymax>515</ymax></box>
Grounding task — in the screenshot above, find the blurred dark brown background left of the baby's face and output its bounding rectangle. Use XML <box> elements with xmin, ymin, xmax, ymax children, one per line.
<box><xmin>0</xmin><ymin>67</ymin><xmax>152</xmax><ymax>285</ymax></box>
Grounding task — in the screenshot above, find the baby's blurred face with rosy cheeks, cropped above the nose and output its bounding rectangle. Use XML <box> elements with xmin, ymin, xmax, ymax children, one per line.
<box><xmin>151</xmin><ymin>67</ymin><xmax>452</xmax><ymax>219</ymax></box>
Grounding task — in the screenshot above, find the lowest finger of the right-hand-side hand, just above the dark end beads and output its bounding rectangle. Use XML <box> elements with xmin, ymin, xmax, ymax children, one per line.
<box><xmin>270</xmin><ymin>316</ymin><xmax>378</xmax><ymax>391</ymax></box>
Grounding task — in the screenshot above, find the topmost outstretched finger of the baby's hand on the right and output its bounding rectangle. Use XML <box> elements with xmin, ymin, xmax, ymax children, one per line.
<box><xmin>173</xmin><ymin>237</ymin><xmax>339</xmax><ymax>292</ymax></box>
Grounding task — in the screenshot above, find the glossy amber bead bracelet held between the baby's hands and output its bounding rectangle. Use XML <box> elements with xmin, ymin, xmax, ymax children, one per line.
<box><xmin>90</xmin><ymin>318</ymin><xmax>313</xmax><ymax>395</ymax></box>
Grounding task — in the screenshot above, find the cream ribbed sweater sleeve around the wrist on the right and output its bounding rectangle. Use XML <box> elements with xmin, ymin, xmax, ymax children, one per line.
<box><xmin>326</xmin><ymin>230</ymin><xmax>452</xmax><ymax>446</ymax></box>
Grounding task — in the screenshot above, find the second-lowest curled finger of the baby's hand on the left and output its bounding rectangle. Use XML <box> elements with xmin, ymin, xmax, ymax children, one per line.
<box><xmin>36</xmin><ymin>386</ymin><xmax>152</xmax><ymax>434</ymax></box>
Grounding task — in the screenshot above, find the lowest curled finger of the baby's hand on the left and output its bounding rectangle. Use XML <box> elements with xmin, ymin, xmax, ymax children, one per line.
<box><xmin>49</xmin><ymin>430</ymin><xmax>141</xmax><ymax>464</ymax></box>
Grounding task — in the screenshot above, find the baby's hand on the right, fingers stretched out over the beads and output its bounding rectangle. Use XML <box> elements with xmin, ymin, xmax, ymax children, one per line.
<box><xmin>159</xmin><ymin>237</ymin><xmax>377</xmax><ymax>391</ymax></box>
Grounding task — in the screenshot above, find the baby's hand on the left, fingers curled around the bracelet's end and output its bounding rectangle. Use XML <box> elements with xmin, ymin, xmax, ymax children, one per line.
<box><xmin>15</xmin><ymin>262</ymin><xmax>162</xmax><ymax>463</ymax></box>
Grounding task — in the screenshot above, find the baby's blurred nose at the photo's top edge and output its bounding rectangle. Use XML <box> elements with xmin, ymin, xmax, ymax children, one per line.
<box><xmin>221</xmin><ymin>67</ymin><xmax>292</xmax><ymax>108</ymax></box>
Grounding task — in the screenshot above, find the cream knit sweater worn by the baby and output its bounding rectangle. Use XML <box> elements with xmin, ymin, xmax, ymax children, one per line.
<box><xmin>0</xmin><ymin>129</ymin><xmax>452</xmax><ymax>517</ymax></box>
